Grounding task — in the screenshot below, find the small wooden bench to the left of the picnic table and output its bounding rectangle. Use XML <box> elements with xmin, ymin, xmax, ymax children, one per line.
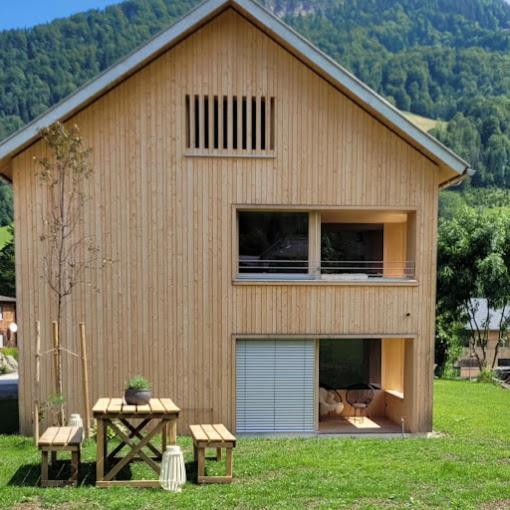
<box><xmin>38</xmin><ymin>427</ymin><xmax>83</xmax><ymax>487</ymax></box>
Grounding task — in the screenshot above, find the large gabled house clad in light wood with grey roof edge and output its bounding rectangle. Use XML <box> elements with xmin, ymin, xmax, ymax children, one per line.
<box><xmin>0</xmin><ymin>0</ymin><xmax>470</xmax><ymax>433</ymax></box>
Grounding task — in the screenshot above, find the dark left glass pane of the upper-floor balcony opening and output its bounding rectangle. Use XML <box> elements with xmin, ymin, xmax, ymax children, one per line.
<box><xmin>239</xmin><ymin>212</ymin><xmax>308</xmax><ymax>274</ymax></box>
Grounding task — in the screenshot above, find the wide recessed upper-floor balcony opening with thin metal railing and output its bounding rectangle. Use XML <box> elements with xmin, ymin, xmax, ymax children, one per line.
<box><xmin>236</xmin><ymin>210</ymin><xmax>416</xmax><ymax>283</ymax></box>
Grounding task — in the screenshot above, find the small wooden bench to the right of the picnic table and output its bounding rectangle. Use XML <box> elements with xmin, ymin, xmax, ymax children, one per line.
<box><xmin>189</xmin><ymin>425</ymin><xmax>236</xmax><ymax>483</ymax></box>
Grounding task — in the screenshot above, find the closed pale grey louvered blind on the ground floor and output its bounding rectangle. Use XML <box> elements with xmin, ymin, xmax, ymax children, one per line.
<box><xmin>236</xmin><ymin>340</ymin><xmax>315</xmax><ymax>433</ymax></box>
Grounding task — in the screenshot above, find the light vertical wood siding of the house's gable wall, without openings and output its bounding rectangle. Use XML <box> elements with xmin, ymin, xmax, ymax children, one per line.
<box><xmin>13</xmin><ymin>10</ymin><xmax>438</xmax><ymax>432</ymax></box>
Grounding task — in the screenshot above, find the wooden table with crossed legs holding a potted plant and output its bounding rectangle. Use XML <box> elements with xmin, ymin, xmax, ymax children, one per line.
<box><xmin>92</xmin><ymin>398</ymin><xmax>180</xmax><ymax>487</ymax></box>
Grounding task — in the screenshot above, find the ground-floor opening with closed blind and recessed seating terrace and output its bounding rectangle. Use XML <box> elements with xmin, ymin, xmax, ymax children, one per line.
<box><xmin>235</xmin><ymin>338</ymin><xmax>412</xmax><ymax>433</ymax></box>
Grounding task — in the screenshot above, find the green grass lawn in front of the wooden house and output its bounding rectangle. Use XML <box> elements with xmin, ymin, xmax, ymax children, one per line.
<box><xmin>0</xmin><ymin>381</ymin><xmax>510</xmax><ymax>510</ymax></box>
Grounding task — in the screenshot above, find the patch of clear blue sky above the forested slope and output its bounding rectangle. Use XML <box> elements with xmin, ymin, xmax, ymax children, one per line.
<box><xmin>0</xmin><ymin>0</ymin><xmax>121</xmax><ymax>30</ymax></box>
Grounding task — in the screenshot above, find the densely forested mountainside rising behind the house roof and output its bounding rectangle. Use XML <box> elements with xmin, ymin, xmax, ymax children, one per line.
<box><xmin>0</xmin><ymin>0</ymin><xmax>510</xmax><ymax>188</ymax></box>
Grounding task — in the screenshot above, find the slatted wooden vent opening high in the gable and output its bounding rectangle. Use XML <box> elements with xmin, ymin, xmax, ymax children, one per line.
<box><xmin>186</xmin><ymin>95</ymin><xmax>275</xmax><ymax>156</ymax></box>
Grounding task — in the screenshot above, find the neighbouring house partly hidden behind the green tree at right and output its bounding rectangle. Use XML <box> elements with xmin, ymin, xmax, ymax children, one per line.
<box><xmin>456</xmin><ymin>298</ymin><xmax>510</xmax><ymax>379</ymax></box>
